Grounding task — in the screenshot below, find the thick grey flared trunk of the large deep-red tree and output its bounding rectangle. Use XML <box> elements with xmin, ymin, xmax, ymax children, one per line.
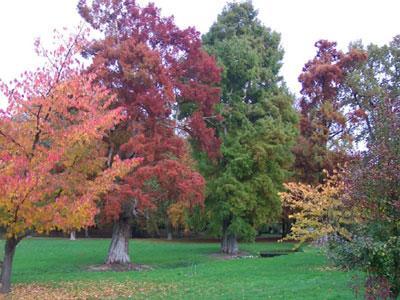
<box><xmin>106</xmin><ymin>218</ymin><xmax>131</xmax><ymax>264</ymax></box>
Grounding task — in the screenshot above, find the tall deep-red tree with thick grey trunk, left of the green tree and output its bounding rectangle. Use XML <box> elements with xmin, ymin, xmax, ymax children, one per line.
<box><xmin>78</xmin><ymin>0</ymin><xmax>220</xmax><ymax>263</ymax></box>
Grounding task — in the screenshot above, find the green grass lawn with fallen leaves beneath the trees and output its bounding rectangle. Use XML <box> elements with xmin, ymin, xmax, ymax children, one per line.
<box><xmin>0</xmin><ymin>238</ymin><xmax>362</xmax><ymax>299</ymax></box>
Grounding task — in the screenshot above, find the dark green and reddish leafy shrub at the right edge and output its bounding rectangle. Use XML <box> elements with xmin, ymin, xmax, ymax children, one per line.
<box><xmin>329</xmin><ymin>99</ymin><xmax>400</xmax><ymax>299</ymax></box>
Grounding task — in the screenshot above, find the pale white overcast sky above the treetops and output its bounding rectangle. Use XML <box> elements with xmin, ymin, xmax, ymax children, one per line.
<box><xmin>0</xmin><ymin>0</ymin><xmax>400</xmax><ymax>107</ymax></box>
